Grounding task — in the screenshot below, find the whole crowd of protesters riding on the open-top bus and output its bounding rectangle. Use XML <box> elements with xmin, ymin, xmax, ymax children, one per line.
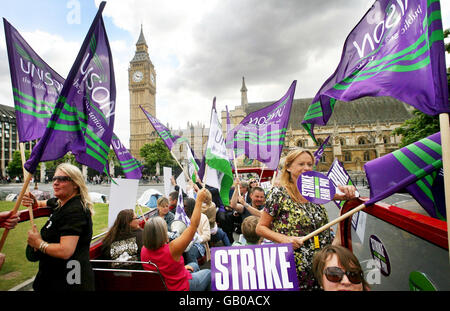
<box><xmin>0</xmin><ymin>149</ymin><xmax>368</xmax><ymax>291</ymax></box>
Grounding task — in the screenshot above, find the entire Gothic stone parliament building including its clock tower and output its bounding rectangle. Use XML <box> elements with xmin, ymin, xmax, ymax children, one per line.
<box><xmin>128</xmin><ymin>28</ymin><xmax>412</xmax><ymax>177</ymax></box>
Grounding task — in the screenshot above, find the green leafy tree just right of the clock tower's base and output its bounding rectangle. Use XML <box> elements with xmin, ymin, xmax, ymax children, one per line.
<box><xmin>140</xmin><ymin>139</ymin><xmax>177</xmax><ymax>174</ymax></box>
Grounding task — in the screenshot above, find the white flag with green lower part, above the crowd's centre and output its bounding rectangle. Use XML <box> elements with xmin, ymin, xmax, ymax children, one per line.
<box><xmin>204</xmin><ymin>97</ymin><xmax>233</xmax><ymax>205</ymax></box>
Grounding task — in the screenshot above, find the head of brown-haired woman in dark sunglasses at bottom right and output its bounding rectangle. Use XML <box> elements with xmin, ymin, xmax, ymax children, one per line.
<box><xmin>313</xmin><ymin>245</ymin><xmax>370</xmax><ymax>291</ymax></box>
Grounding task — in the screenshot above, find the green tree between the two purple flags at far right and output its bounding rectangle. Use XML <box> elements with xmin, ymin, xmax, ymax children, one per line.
<box><xmin>392</xmin><ymin>109</ymin><xmax>440</xmax><ymax>148</ymax></box>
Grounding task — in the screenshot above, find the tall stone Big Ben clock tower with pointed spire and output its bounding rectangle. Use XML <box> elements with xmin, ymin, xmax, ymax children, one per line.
<box><xmin>128</xmin><ymin>26</ymin><xmax>157</xmax><ymax>159</ymax></box>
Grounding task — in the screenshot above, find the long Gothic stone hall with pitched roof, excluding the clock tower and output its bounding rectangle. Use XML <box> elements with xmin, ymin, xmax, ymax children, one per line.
<box><xmin>222</xmin><ymin>78</ymin><xmax>412</xmax><ymax>173</ymax></box>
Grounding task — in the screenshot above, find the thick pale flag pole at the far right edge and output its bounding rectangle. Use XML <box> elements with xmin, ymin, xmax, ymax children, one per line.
<box><xmin>439</xmin><ymin>113</ymin><xmax>450</xmax><ymax>261</ymax></box>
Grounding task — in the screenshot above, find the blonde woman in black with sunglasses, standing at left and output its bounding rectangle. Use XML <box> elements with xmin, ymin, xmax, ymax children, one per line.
<box><xmin>22</xmin><ymin>163</ymin><xmax>94</xmax><ymax>291</ymax></box>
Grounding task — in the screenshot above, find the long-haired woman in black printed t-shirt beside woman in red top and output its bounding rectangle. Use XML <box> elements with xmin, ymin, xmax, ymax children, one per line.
<box><xmin>102</xmin><ymin>209</ymin><xmax>143</xmax><ymax>270</ymax></box>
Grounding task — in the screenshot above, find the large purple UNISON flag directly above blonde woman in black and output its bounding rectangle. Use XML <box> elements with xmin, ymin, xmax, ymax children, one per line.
<box><xmin>24</xmin><ymin>1</ymin><xmax>116</xmax><ymax>173</ymax></box>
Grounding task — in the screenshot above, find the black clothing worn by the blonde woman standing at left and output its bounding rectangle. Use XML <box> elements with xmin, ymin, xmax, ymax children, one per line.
<box><xmin>33</xmin><ymin>196</ymin><xmax>94</xmax><ymax>291</ymax></box>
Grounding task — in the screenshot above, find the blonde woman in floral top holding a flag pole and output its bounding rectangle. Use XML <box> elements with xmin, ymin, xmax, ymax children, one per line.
<box><xmin>256</xmin><ymin>149</ymin><xmax>355</xmax><ymax>290</ymax></box>
